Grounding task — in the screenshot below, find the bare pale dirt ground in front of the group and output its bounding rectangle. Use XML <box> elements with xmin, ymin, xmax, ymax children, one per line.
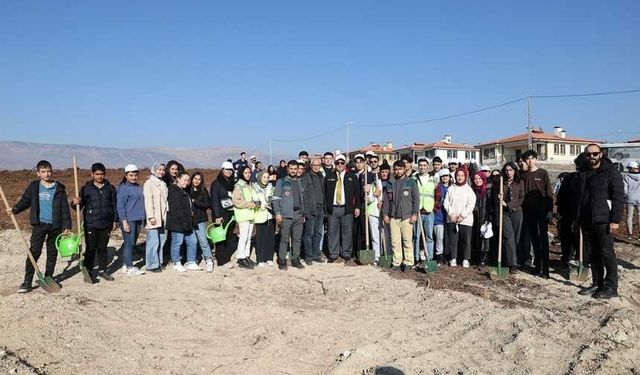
<box><xmin>0</xmin><ymin>174</ymin><xmax>640</xmax><ymax>374</ymax></box>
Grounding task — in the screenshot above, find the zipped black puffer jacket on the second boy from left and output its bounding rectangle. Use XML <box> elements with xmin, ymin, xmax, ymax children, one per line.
<box><xmin>80</xmin><ymin>180</ymin><xmax>118</xmax><ymax>229</ymax></box>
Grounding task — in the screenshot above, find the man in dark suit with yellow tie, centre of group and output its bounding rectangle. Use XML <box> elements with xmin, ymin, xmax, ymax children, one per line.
<box><xmin>324</xmin><ymin>155</ymin><xmax>360</xmax><ymax>265</ymax></box>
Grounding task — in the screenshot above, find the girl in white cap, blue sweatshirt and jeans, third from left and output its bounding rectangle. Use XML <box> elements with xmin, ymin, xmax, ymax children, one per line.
<box><xmin>116</xmin><ymin>164</ymin><xmax>145</xmax><ymax>276</ymax></box>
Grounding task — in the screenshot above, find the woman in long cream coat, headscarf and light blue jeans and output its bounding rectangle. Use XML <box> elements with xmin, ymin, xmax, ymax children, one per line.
<box><xmin>143</xmin><ymin>162</ymin><xmax>169</xmax><ymax>272</ymax></box>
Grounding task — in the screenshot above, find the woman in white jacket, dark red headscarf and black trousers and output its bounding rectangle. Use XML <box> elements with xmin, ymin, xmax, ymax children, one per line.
<box><xmin>444</xmin><ymin>169</ymin><xmax>476</xmax><ymax>268</ymax></box>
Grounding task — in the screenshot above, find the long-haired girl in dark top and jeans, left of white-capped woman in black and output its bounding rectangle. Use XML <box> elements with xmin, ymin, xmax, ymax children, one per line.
<box><xmin>189</xmin><ymin>172</ymin><xmax>213</xmax><ymax>272</ymax></box>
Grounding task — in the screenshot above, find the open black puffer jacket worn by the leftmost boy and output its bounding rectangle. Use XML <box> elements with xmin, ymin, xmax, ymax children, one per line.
<box><xmin>11</xmin><ymin>180</ymin><xmax>71</xmax><ymax>229</ymax></box>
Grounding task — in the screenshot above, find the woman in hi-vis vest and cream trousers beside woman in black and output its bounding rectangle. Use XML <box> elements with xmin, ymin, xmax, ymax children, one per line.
<box><xmin>233</xmin><ymin>167</ymin><xmax>256</xmax><ymax>269</ymax></box>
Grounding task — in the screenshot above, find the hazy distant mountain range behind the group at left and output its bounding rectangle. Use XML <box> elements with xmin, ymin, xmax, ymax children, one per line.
<box><xmin>0</xmin><ymin>141</ymin><xmax>282</xmax><ymax>170</ymax></box>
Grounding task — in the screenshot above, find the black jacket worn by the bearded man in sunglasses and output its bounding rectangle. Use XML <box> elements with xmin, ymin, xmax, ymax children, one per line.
<box><xmin>576</xmin><ymin>158</ymin><xmax>624</xmax><ymax>224</ymax></box>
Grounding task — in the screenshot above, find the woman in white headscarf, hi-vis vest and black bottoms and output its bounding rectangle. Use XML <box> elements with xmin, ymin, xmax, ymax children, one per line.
<box><xmin>253</xmin><ymin>172</ymin><xmax>276</xmax><ymax>267</ymax></box>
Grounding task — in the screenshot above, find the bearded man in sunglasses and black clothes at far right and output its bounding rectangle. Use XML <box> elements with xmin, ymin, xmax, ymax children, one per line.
<box><xmin>576</xmin><ymin>144</ymin><xmax>624</xmax><ymax>299</ymax></box>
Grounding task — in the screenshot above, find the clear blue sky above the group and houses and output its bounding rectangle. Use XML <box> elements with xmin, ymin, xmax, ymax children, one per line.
<box><xmin>0</xmin><ymin>1</ymin><xmax>640</xmax><ymax>153</ymax></box>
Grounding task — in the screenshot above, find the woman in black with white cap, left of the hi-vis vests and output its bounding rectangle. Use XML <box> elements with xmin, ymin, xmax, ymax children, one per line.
<box><xmin>209</xmin><ymin>161</ymin><xmax>238</xmax><ymax>266</ymax></box>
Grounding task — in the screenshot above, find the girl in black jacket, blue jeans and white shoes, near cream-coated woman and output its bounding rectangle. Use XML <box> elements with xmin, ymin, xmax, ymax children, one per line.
<box><xmin>167</xmin><ymin>172</ymin><xmax>202</xmax><ymax>272</ymax></box>
